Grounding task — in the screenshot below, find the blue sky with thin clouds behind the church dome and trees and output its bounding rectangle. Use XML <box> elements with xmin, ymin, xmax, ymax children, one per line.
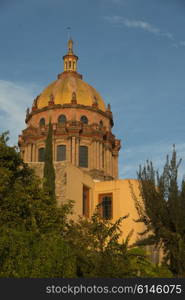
<box><xmin>0</xmin><ymin>0</ymin><xmax>185</xmax><ymax>178</ymax></box>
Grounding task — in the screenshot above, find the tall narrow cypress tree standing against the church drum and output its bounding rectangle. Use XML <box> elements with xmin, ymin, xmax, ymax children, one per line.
<box><xmin>44</xmin><ymin>120</ymin><xmax>56</xmax><ymax>202</ymax></box>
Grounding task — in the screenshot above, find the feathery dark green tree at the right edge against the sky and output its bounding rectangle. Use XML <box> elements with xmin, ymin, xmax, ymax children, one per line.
<box><xmin>131</xmin><ymin>147</ymin><xmax>185</xmax><ymax>277</ymax></box>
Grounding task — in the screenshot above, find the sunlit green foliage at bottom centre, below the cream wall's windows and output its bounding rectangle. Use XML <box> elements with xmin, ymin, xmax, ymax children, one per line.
<box><xmin>65</xmin><ymin>211</ymin><xmax>170</xmax><ymax>278</ymax></box>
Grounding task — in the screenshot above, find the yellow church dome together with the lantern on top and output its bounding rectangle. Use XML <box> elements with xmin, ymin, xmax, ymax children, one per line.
<box><xmin>36</xmin><ymin>39</ymin><xmax>106</xmax><ymax>112</ymax></box>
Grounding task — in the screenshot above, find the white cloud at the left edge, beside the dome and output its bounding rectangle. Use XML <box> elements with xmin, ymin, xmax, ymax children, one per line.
<box><xmin>0</xmin><ymin>80</ymin><xmax>38</xmax><ymax>144</ymax></box>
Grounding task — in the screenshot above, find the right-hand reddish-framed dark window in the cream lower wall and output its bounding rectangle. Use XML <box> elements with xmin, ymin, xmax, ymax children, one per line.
<box><xmin>99</xmin><ymin>194</ymin><xmax>112</xmax><ymax>220</ymax></box>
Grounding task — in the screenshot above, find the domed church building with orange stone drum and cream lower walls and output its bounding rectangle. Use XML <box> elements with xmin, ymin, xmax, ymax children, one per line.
<box><xmin>18</xmin><ymin>39</ymin><xmax>144</xmax><ymax>243</ymax></box>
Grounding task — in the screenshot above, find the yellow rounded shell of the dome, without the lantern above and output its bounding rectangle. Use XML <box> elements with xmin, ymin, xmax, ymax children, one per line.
<box><xmin>37</xmin><ymin>72</ymin><xmax>106</xmax><ymax>111</ymax></box>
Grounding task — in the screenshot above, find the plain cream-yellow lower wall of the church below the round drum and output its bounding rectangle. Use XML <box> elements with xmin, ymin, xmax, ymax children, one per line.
<box><xmin>29</xmin><ymin>162</ymin><xmax>144</xmax><ymax>244</ymax></box>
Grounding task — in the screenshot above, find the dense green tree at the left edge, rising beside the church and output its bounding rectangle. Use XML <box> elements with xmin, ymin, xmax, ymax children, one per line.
<box><xmin>0</xmin><ymin>134</ymin><xmax>76</xmax><ymax>277</ymax></box>
